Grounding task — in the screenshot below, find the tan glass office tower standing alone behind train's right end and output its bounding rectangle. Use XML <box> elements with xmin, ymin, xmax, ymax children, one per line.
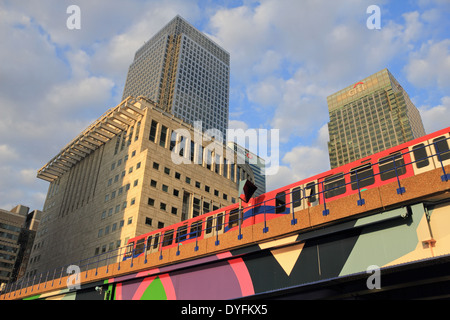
<box><xmin>327</xmin><ymin>69</ymin><xmax>425</xmax><ymax>168</ymax></box>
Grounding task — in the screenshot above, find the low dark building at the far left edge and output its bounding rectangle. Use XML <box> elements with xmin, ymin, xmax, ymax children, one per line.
<box><xmin>0</xmin><ymin>205</ymin><xmax>41</xmax><ymax>288</ymax></box>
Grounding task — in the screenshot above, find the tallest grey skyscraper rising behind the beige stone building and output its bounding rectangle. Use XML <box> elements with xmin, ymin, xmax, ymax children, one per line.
<box><xmin>122</xmin><ymin>16</ymin><xmax>230</xmax><ymax>139</ymax></box>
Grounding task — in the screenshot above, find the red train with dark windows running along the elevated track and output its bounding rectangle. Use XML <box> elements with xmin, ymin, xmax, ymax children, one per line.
<box><xmin>124</xmin><ymin>127</ymin><xmax>450</xmax><ymax>260</ymax></box>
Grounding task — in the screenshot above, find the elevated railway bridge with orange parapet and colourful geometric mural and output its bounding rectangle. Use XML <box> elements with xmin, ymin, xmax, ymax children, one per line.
<box><xmin>0</xmin><ymin>159</ymin><xmax>450</xmax><ymax>301</ymax></box>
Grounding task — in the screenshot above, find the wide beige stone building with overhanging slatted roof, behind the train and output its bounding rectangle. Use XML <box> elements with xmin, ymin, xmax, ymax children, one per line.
<box><xmin>27</xmin><ymin>98</ymin><xmax>241</xmax><ymax>276</ymax></box>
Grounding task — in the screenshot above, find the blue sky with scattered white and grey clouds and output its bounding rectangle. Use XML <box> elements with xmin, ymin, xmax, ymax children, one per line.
<box><xmin>0</xmin><ymin>0</ymin><xmax>450</xmax><ymax>210</ymax></box>
